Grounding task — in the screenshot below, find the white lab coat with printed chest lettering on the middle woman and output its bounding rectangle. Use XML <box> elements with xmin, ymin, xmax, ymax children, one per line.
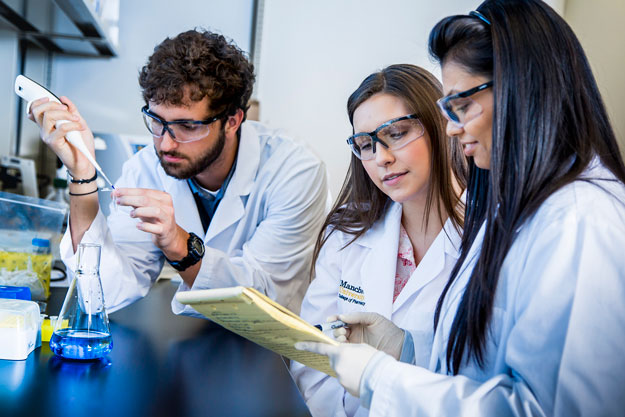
<box><xmin>291</xmin><ymin>203</ymin><xmax>460</xmax><ymax>417</ymax></box>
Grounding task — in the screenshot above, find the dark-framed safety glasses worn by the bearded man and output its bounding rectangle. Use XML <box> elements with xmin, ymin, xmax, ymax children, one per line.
<box><xmin>141</xmin><ymin>106</ymin><xmax>225</xmax><ymax>143</ymax></box>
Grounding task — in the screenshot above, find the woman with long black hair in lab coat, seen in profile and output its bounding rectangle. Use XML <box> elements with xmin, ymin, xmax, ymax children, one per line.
<box><xmin>294</xmin><ymin>0</ymin><xmax>625</xmax><ymax>416</ymax></box>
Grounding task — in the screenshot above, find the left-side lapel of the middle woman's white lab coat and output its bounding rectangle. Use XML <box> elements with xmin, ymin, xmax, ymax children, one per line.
<box><xmin>354</xmin><ymin>203</ymin><xmax>401</xmax><ymax>319</ymax></box>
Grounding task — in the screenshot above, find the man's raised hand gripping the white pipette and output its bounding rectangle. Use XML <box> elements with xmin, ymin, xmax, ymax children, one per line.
<box><xmin>28</xmin><ymin>97</ymin><xmax>95</xmax><ymax>179</ymax></box>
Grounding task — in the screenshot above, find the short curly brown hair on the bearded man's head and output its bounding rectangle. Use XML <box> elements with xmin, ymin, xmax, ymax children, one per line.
<box><xmin>139</xmin><ymin>30</ymin><xmax>255</xmax><ymax>120</ymax></box>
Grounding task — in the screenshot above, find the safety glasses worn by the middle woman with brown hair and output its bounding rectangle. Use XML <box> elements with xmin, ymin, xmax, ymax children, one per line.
<box><xmin>347</xmin><ymin>114</ymin><xmax>425</xmax><ymax>161</ymax></box>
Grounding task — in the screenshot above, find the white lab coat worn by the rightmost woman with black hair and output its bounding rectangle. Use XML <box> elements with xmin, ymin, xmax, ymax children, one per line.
<box><xmin>361</xmin><ymin>160</ymin><xmax>625</xmax><ymax>417</ymax></box>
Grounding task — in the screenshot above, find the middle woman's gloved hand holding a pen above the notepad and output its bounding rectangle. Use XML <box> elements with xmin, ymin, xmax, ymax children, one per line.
<box><xmin>328</xmin><ymin>313</ymin><xmax>404</xmax><ymax>360</ymax></box>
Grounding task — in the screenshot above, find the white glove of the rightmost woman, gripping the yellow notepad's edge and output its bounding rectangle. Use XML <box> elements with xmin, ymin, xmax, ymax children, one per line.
<box><xmin>295</xmin><ymin>342</ymin><xmax>378</xmax><ymax>397</ymax></box>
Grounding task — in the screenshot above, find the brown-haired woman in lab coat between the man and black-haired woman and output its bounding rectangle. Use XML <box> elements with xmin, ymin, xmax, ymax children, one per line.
<box><xmin>293</xmin><ymin>64</ymin><xmax>466</xmax><ymax>416</ymax></box>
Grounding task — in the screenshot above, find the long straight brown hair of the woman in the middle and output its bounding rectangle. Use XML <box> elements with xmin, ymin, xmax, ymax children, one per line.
<box><xmin>311</xmin><ymin>64</ymin><xmax>466</xmax><ymax>272</ymax></box>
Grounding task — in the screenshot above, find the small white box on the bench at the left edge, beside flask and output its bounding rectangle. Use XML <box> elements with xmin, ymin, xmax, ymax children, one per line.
<box><xmin>0</xmin><ymin>298</ymin><xmax>41</xmax><ymax>360</ymax></box>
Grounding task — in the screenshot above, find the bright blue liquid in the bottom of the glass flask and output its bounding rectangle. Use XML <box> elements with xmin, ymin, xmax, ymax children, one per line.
<box><xmin>50</xmin><ymin>329</ymin><xmax>113</xmax><ymax>360</ymax></box>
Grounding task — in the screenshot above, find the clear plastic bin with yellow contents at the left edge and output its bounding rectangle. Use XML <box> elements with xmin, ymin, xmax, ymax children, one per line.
<box><xmin>0</xmin><ymin>192</ymin><xmax>67</xmax><ymax>300</ymax></box>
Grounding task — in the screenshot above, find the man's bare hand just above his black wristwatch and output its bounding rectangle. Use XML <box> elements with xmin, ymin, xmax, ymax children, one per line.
<box><xmin>111</xmin><ymin>188</ymin><xmax>189</xmax><ymax>260</ymax></box>
